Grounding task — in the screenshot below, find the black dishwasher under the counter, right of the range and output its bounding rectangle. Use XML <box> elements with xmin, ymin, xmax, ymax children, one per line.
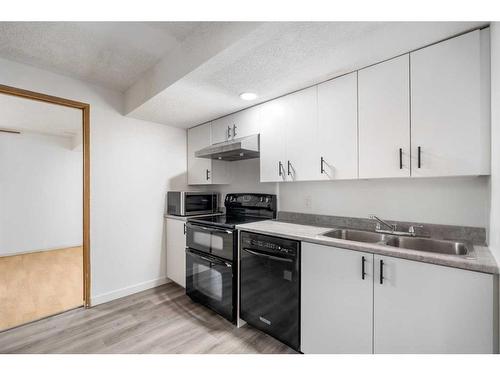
<box><xmin>240</xmin><ymin>232</ymin><xmax>300</xmax><ymax>351</ymax></box>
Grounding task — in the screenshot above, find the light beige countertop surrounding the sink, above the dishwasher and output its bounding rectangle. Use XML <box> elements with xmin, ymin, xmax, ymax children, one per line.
<box><xmin>236</xmin><ymin>220</ymin><xmax>500</xmax><ymax>274</ymax></box>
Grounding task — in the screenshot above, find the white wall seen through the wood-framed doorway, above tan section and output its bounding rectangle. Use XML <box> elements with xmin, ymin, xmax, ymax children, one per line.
<box><xmin>0</xmin><ymin>132</ymin><xmax>82</xmax><ymax>256</ymax></box>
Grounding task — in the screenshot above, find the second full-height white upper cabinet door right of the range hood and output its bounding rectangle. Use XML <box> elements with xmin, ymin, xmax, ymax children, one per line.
<box><xmin>283</xmin><ymin>86</ymin><xmax>321</xmax><ymax>181</ymax></box>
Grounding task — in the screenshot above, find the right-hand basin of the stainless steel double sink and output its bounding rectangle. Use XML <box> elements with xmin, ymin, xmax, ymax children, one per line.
<box><xmin>386</xmin><ymin>237</ymin><xmax>469</xmax><ymax>255</ymax></box>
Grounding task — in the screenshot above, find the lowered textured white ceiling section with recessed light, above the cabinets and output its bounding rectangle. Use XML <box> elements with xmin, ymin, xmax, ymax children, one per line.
<box><xmin>130</xmin><ymin>22</ymin><xmax>484</xmax><ymax>128</ymax></box>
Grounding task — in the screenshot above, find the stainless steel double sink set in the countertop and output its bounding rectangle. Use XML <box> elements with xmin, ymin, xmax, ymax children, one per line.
<box><xmin>322</xmin><ymin>229</ymin><xmax>472</xmax><ymax>256</ymax></box>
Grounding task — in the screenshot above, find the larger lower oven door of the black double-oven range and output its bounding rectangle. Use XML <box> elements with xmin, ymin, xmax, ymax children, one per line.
<box><xmin>186</xmin><ymin>248</ymin><xmax>236</xmax><ymax>323</ymax></box>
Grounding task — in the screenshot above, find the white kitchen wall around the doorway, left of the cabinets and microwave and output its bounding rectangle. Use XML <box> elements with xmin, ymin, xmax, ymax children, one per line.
<box><xmin>0</xmin><ymin>59</ymin><xmax>186</xmax><ymax>304</ymax></box>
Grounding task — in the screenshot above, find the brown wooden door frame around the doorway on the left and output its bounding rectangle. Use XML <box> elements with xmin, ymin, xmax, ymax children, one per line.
<box><xmin>0</xmin><ymin>84</ymin><xmax>91</xmax><ymax>308</ymax></box>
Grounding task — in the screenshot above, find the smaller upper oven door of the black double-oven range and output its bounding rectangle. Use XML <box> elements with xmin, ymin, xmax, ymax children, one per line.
<box><xmin>186</xmin><ymin>222</ymin><xmax>237</xmax><ymax>261</ymax></box>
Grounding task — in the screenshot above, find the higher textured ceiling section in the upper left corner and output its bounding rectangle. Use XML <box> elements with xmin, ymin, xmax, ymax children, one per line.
<box><xmin>0</xmin><ymin>22</ymin><xmax>202</xmax><ymax>91</ymax></box>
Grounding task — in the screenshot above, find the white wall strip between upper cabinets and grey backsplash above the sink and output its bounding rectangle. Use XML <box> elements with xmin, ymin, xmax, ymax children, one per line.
<box><xmin>279</xmin><ymin>177</ymin><xmax>489</xmax><ymax>227</ymax></box>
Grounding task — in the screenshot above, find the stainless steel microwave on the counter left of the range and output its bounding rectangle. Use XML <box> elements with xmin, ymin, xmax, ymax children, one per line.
<box><xmin>166</xmin><ymin>191</ymin><xmax>219</xmax><ymax>216</ymax></box>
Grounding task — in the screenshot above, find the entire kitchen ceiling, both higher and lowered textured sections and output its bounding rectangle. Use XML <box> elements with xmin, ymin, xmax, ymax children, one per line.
<box><xmin>0</xmin><ymin>22</ymin><xmax>485</xmax><ymax>128</ymax></box>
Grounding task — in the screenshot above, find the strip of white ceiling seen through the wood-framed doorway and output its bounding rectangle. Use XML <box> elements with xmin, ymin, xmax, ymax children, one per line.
<box><xmin>0</xmin><ymin>94</ymin><xmax>82</xmax><ymax>137</ymax></box>
